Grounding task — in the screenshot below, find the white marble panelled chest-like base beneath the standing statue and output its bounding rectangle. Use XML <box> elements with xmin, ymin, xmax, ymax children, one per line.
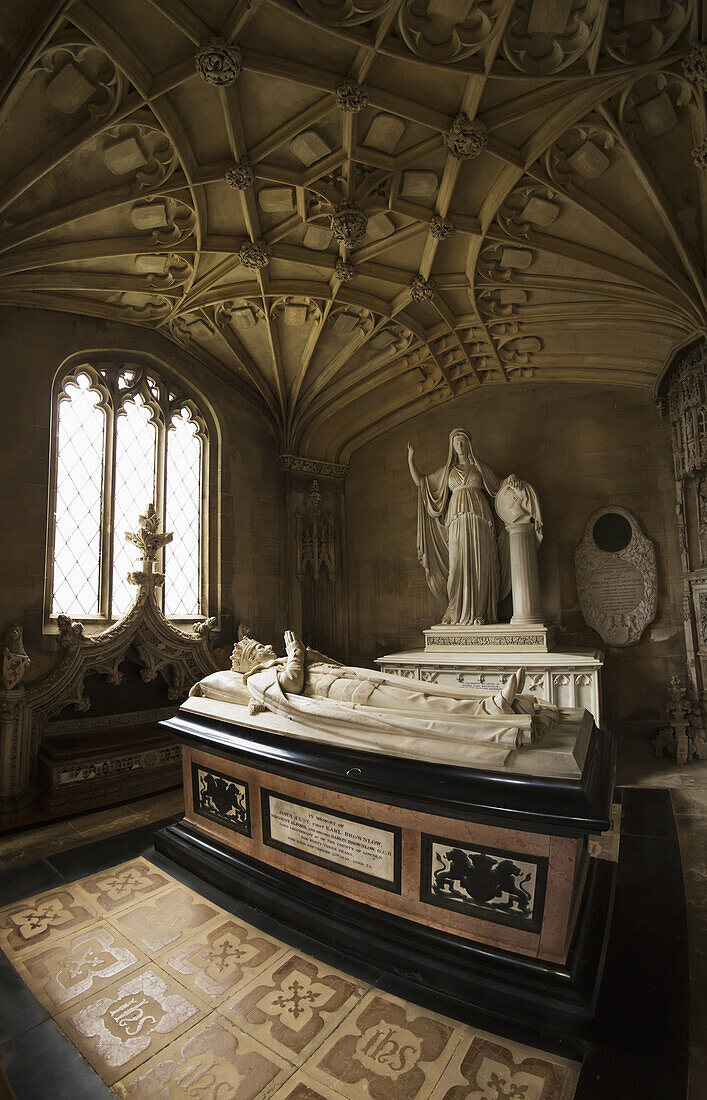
<box><xmin>376</xmin><ymin>646</ymin><xmax>604</xmax><ymax>726</ymax></box>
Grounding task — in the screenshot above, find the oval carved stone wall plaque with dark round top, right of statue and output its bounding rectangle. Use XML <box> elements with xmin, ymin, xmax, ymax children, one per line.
<box><xmin>575</xmin><ymin>507</ymin><xmax>658</xmax><ymax>646</ymax></box>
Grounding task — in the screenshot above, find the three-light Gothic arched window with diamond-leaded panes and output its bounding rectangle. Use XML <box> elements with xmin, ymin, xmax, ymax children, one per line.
<box><xmin>47</xmin><ymin>363</ymin><xmax>208</xmax><ymax>620</ymax></box>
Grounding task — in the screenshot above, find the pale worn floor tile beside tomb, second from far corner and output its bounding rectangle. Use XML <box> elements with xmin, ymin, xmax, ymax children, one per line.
<box><xmin>111</xmin><ymin>880</ymin><xmax>227</xmax><ymax>956</ymax></box>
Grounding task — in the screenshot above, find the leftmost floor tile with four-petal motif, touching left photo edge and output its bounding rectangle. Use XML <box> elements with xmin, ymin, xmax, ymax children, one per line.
<box><xmin>0</xmin><ymin>883</ymin><xmax>98</xmax><ymax>958</ymax></box>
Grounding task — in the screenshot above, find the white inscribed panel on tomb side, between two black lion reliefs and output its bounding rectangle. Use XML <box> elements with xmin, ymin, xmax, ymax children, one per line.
<box><xmin>261</xmin><ymin>790</ymin><xmax>401</xmax><ymax>893</ymax></box>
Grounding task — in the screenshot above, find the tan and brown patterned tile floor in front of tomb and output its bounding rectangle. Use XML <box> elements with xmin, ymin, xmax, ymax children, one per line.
<box><xmin>0</xmin><ymin>857</ymin><xmax>579</xmax><ymax>1100</ymax></box>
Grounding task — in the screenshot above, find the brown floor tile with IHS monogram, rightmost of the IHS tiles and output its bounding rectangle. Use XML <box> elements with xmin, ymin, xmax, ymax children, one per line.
<box><xmin>308</xmin><ymin>990</ymin><xmax>464</xmax><ymax>1100</ymax></box>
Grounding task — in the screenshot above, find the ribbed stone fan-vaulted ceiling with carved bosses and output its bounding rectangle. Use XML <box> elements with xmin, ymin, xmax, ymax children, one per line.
<box><xmin>0</xmin><ymin>0</ymin><xmax>707</xmax><ymax>462</ymax></box>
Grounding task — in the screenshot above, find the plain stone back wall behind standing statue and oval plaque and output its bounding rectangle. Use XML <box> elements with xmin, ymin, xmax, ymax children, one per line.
<box><xmin>346</xmin><ymin>383</ymin><xmax>685</xmax><ymax>729</ymax></box>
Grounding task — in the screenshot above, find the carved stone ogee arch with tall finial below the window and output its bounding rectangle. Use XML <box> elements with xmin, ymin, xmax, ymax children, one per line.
<box><xmin>0</xmin><ymin>507</ymin><xmax>218</xmax><ymax>814</ymax></box>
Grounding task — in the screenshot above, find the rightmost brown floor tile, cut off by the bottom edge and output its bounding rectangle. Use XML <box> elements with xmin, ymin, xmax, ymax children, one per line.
<box><xmin>432</xmin><ymin>1032</ymin><xmax>581</xmax><ymax>1100</ymax></box>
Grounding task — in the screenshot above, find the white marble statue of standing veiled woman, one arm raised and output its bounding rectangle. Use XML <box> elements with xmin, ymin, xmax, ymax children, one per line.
<box><xmin>408</xmin><ymin>428</ymin><xmax>542</xmax><ymax>626</ymax></box>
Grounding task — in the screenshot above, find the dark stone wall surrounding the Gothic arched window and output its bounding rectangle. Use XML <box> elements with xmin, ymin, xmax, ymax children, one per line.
<box><xmin>0</xmin><ymin>308</ymin><xmax>285</xmax><ymax>686</ymax></box>
